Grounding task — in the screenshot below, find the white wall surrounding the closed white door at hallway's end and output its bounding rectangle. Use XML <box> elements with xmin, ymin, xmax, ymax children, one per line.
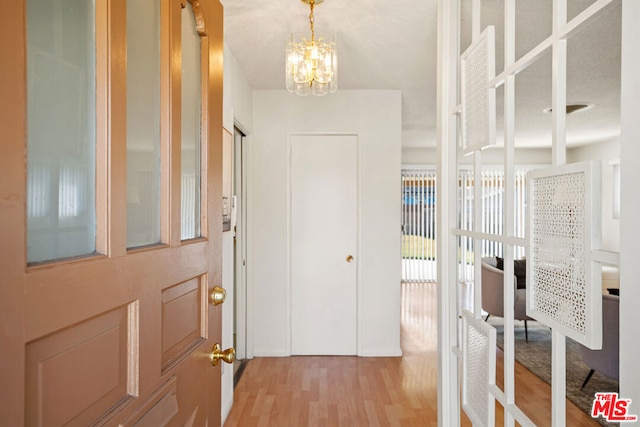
<box><xmin>249</xmin><ymin>91</ymin><xmax>401</xmax><ymax>356</ymax></box>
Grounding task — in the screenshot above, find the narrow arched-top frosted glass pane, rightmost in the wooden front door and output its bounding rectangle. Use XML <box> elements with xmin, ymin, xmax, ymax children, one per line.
<box><xmin>181</xmin><ymin>2</ymin><xmax>202</xmax><ymax>239</ymax></box>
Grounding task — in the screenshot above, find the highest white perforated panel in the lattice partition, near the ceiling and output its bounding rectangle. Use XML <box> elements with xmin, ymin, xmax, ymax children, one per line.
<box><xmin>460</xmin><ymin>26</ymin><xmax>496</xmax><ymax>154</ymax></box>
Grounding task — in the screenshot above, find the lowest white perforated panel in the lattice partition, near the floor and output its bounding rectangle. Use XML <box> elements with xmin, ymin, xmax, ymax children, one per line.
<box><xmin>462</xmin><ymin>310</ymin><xmax>496</xmax><ymax>426</ymax></box>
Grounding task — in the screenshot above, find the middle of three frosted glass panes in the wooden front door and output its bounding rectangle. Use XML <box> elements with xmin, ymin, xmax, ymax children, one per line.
<box><xmin>127</xmin><ymin>0</ymin><xmax>160</xmax><ymax>248</ymax></box>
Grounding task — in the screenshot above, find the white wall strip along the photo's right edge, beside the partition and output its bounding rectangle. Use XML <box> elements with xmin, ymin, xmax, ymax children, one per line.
<box><xmin>620</xmin><ymin>1</ymin><xmax>640</xmax><ymax>408</ymax></box>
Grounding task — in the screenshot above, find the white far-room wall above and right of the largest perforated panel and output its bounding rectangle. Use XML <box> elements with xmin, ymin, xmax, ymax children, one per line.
<box><xmin>567</xmin><ymin>139</ymin><xmax>620</xmax><ymax>252</ymax></box>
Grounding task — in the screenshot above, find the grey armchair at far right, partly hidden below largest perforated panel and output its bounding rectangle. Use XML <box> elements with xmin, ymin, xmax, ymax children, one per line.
<box><xmin>580</xmin><ymin>294</ymin><xmax>620</xmax><ymax>389</ymax></box>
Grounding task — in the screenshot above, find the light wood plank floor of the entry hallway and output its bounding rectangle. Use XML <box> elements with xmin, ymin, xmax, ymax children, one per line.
<box><xmin>225</xmin><ymin>283</ymin><xmax>598</xmax><ymax>427</ymax></box>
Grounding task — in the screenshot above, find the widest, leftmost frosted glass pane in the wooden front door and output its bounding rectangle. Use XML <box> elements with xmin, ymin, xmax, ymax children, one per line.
<box><xmin>27</xmin><ymin>0</ymin><xmax>96</xmax><ymax>263</ymax></box>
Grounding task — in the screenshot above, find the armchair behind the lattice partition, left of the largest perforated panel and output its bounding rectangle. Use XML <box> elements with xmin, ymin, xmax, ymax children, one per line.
<box><xmin>482</xmin><ymin>257</ymin><xmax>533</xmax><ymax>341</ymax></box>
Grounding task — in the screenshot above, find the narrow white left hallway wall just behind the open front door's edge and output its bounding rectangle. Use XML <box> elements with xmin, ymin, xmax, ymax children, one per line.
<box><xmin>222</xmin><ymin>43</ymin><xmax>253</xmax><ymax>424</ymax></box>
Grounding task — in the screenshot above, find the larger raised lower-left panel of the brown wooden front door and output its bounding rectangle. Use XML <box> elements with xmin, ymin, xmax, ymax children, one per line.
<box><xmin>26</xmin><ymin>303</ymin><xmax>138</xmax><ymax>426</ymax></box>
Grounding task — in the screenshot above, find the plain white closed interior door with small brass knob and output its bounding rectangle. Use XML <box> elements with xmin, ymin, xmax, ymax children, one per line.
<box><xmin>291</xmin><ymin>135</ymin><xmax>358</xmax><ymax>355</ymax></box>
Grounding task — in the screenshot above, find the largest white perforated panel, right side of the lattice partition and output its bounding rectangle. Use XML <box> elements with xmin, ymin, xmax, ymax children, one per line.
<box><xmin>527</xmin><ymin>163</ymin><xmax>602</xmax><ymax>347</ymax></box>
